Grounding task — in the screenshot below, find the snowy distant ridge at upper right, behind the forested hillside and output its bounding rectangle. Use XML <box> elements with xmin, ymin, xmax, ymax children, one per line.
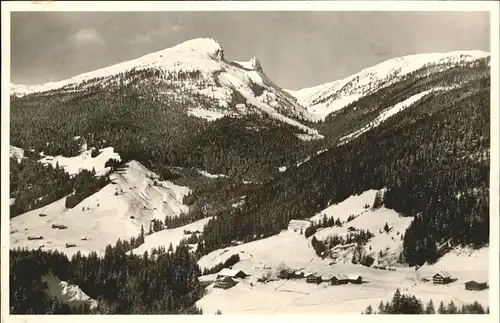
<box><xmin>288</xmin><ymin>51</ymin><xmax>490</xmax><ymax>119</ymax></box>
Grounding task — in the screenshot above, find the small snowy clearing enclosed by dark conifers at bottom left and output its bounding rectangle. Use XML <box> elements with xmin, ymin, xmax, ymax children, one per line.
<box><xmin>42</xmin><ymin>274</ymin><xmax>97</xmax><ymax>309</ymax></box>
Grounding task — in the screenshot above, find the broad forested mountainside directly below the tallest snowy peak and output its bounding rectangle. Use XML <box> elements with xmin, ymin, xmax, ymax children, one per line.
<box><xmin>11</xmin><ymin>72</ymin><xmax>316</xmax><ymax>185</ymax></box>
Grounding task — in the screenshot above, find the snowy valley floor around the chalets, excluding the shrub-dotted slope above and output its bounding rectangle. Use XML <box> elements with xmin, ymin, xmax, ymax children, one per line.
<box><xmin>197</xmin><ymin>232</ymin><xmax>489</xmax><ymax>314</ymax></box>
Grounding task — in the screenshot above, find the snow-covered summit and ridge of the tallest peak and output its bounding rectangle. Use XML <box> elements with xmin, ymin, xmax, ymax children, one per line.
<box><xmin>11</xmin><ymin>38</ymin><xmax>322</xmax><ymax>139</ymax></box>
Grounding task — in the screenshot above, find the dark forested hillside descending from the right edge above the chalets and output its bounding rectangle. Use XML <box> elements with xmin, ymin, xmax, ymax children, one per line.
<box><xmin>198</xmin><ymin>66</ymin><xmax>490</xmax><ymax>265</ymax></box>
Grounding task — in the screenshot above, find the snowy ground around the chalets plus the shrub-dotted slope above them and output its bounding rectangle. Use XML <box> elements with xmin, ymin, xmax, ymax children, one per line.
<box><xmin>197</xmin><ymin>190</ymin><xmax>489</xmax><ymax>314</ymax></box>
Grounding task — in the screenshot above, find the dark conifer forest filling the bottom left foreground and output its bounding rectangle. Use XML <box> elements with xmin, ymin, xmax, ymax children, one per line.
<box><xmin>9</xmin><ymin>239</ymin><xmax>202</xmax><ymax>314</ymax></box>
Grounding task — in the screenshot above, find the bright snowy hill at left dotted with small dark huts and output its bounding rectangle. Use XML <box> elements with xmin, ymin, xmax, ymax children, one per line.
<box><xmin>10</xmin><ymin>161</ymin><xmax>190</xmax><ymax>256</ymax></box>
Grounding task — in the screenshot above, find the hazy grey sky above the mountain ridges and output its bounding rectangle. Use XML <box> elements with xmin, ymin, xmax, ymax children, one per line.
<box><xmin>10</xmin><ymin>11</ymin><xmax>490</xmax><ymax>89</ymax></box>
